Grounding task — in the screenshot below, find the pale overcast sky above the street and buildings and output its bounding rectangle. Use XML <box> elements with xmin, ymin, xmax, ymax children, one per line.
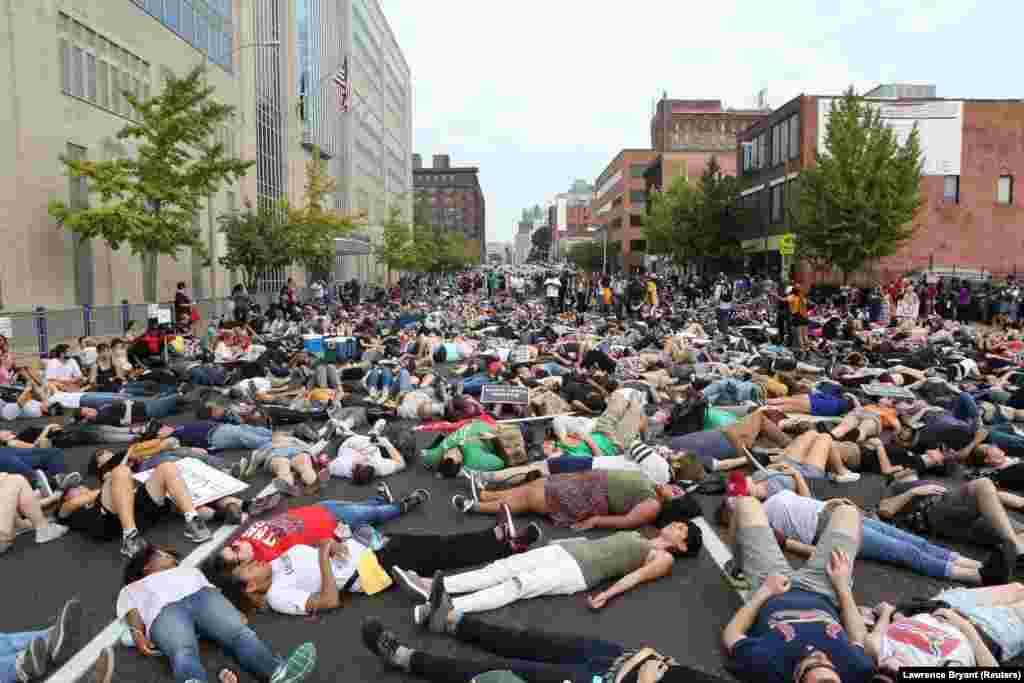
<box><xmin>381</xmin><ymin>0</ymin><xmax>1024</xmax><ymax>241</ymax></box>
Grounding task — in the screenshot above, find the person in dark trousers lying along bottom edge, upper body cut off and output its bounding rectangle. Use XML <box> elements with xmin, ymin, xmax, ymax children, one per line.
<box><xmin>362</xmin><ymin>614</ymin><xmax>724</xmax><ymax>683</ymax></box>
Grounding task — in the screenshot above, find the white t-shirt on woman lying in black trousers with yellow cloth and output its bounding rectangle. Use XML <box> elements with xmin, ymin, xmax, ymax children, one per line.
<box><xmin>266</xmin><ymin>539</ymin><xmax>368</xmax><ymax>615</ymax></box>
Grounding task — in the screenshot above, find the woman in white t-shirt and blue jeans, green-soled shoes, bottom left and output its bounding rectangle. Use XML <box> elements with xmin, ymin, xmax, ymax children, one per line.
<box><xmin>117</xmin><ymin>546</ymin><xmax>316</xmax><ymax>683</ymax></box>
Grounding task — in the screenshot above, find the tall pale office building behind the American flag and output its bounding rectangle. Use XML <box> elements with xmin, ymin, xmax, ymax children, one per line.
<box><xmin>292</xmin><ymin>0</ymin><xmax>413</xmax><ymax>282</ymax></box>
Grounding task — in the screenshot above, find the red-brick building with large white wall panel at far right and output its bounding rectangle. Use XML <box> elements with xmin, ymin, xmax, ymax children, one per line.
<box><xmin>736</xmin><ymin>85</ymin><xmax>1024</xmax><ymax>280</ymax></box>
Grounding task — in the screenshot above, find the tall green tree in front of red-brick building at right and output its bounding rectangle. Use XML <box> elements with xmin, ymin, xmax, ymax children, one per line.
<box><xmin>790</xmin><ymin>88</ymin><xmax>922</xmax><ymax>283</ymax></box>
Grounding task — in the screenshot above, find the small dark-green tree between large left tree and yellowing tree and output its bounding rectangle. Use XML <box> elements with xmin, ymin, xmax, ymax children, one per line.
<box><xmin>217</xmin><ymin>202</ymin><xmax>292</xmax><ymax>292</ymax></box>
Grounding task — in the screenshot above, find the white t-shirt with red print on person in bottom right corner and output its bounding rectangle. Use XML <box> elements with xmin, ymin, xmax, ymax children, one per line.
<box><xmin>882</xmin><ymin>614</ymin><xmax>976</xmax><ymax>667</ymax></box>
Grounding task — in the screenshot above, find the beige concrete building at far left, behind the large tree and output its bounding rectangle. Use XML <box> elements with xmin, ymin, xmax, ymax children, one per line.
<box><xmin>0</xmin><ymin>0</ymin><xmax>247</xmax><ymax>309</ymax></box>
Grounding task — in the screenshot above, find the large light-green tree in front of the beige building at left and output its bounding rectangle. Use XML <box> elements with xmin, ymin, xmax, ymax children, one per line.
<box><xmin>49</xmin><ymin>68</ymin><xmax>253</xmax><ymax>301</ymax></box>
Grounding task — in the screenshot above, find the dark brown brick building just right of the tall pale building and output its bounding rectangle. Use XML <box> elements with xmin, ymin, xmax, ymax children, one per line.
<box><xmin>413</xmin><ymin>155</ymin><xmax>487</xmax><ymax>262</ymax></box>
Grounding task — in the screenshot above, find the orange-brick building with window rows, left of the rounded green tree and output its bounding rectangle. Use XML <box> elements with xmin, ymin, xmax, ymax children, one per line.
<box><xmin>591</xmin><ymin>150</ymin><xmax>657</xmax><ymax>270</ymax></box>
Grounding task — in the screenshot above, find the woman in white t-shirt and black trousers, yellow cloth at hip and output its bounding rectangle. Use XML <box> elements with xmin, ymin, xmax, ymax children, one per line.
<box><xmin>210</xmin><ymin>501</ymin><xmax>541</xmax><ymax>614</ymax></box>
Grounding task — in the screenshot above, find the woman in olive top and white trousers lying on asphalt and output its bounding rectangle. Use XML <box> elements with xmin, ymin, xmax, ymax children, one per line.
<box><xmin>403</xmin><ymin>520</ymin><xmax>703</xmax><ymax>633</ymax></box>
